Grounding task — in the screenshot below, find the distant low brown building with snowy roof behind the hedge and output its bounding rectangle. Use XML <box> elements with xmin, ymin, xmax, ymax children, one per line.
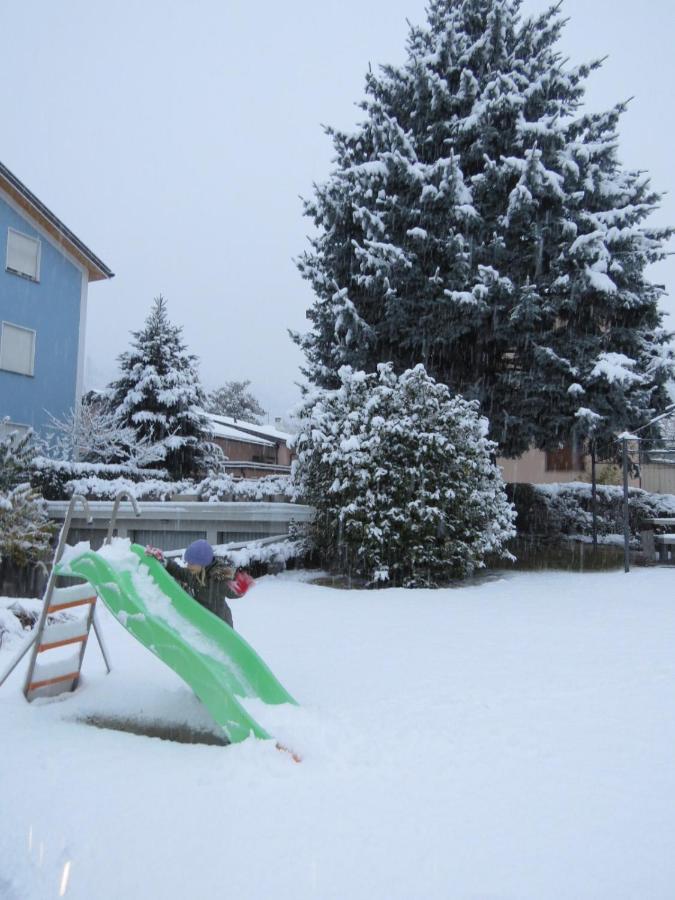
<box><xmin>208</xmin><ymin>414</ymin><xmax>293</xmax><ymax>478</ymax></box>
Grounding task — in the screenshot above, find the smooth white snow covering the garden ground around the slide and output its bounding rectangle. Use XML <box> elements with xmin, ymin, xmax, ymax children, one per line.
<box><xmin>0</xmin><ymin>569</ymin><xmax>675</xmax><ymax>900</ymax></box>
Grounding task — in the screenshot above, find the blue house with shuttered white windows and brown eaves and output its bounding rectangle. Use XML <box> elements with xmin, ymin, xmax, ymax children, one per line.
<box><xmin>0</xmin><ymin>163</ymin><xmax>113</xmax><ymax>436</ymax></box>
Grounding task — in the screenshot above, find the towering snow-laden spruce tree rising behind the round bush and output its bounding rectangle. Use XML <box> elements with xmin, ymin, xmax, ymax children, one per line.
<box><xmin>295</xmin><ymin>0</ymin><xmax>672</xmax><ymax>455</ymax></box>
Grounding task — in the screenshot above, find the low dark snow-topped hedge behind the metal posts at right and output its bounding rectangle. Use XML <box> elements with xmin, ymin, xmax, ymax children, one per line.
<box><xmin>507</xmin><ymin>482</ymin><xmax>675</xmax><ymax>541</ymax></box>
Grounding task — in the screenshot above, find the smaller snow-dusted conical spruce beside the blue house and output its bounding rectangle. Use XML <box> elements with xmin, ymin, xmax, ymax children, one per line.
<box><xmin>108</xmin><ymin>296</ymin><xmax>213</xmax><ymax>478</ymax></box>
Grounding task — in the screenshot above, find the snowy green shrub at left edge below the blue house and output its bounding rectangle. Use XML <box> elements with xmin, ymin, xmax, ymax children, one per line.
<box><xmin>0</xmin><ymin>432</ymin><xmax>54</xmax><ymax>567</ymax></box>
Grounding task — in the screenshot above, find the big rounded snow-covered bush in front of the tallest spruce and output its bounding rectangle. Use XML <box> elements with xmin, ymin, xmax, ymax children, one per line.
<box><xmin>292</xmin><ymin>364</ymin><xmax>515</xmax><ymax>586</ymax></box>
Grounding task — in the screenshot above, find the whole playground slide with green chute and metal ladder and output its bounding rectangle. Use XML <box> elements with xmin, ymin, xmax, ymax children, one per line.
<box><xmin>0</xmin><ymin>492</ymin><xmax>297</xmax><ymax>749</ymax></box>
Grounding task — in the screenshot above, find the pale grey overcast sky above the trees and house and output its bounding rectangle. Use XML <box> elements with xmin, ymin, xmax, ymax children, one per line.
<box><xmin>0</xmin><ymin>0</ymin><xmax>675</xmax><ymax>417</ymax></box>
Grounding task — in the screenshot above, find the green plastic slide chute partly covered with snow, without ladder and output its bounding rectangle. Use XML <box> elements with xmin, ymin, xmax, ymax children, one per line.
<box><xmin>57</xmin><ymin>544</ymin><xmax>297</xmax><ymax>743</ymax></box>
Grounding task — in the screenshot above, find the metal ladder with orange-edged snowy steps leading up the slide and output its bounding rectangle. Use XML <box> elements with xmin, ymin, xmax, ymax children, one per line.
<box><xmin>0</xmin><ymin>491</ymin><xmax>140</xmax><ymax>701</ymax></box>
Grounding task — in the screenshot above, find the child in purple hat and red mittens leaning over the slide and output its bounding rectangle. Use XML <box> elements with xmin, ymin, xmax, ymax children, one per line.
<box><xmin>145</xmin><ymin>541</ymin><xmax>254</xmax><ymax>628</ymax></box>
